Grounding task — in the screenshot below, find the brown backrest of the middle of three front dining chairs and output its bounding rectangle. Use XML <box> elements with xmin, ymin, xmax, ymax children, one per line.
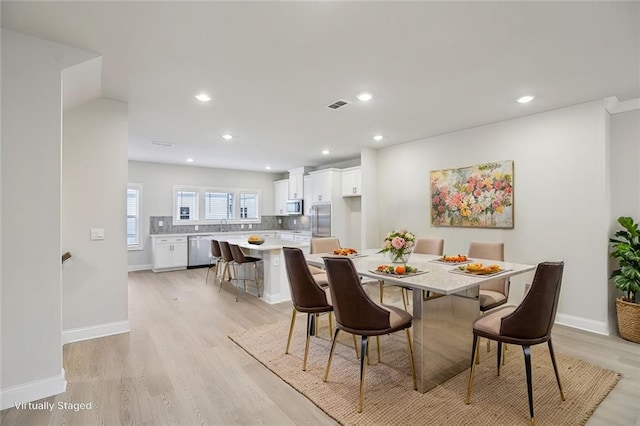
<box><xmin>324</xmin><ymin>257</ymin><xmax>390</xmax><ymax>334</ymax></box>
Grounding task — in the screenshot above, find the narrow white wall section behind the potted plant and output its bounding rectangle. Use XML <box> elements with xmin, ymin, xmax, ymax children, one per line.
<box><xmin>609</xmin><ymin>110</ymin><xmax>640</xmax><ymax>333</ymax></box>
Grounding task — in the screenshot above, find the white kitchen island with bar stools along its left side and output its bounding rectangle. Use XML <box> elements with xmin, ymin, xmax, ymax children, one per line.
<box><xmin>222</xmin><ymin>238</ymin><xmax>309</xmax><ymax>303</ymax></box>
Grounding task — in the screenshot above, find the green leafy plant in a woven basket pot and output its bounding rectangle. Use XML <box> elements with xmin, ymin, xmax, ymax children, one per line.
<box><xmin>609</xmin><ymin>216</ymin><xmax>640</xmax><ymax>343</ymax></box>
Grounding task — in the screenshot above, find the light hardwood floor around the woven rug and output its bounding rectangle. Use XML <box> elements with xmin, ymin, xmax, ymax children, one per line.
<box><xmin>0</xmin><ymin>269</ymin><xmax>640</xmax><ymax>425</ymax></box>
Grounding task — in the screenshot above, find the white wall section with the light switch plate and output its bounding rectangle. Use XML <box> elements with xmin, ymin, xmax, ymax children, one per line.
<box><xmin>61</xmin><ymin>99</ymin><xmax>129</xmax><ymax>343</ymax></box>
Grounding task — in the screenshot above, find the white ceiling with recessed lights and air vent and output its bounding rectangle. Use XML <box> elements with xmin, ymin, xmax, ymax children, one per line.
<box><xmin>1</xmin><ymin>1</ymin><xmax>640</xmax><ymax>171</ymax></box>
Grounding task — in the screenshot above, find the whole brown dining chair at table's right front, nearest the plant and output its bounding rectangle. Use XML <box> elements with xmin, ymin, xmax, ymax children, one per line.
<box><xmin>465</xmin><ymin>262</ymin><xmax>565</xmax><ymax>426</ymax></box>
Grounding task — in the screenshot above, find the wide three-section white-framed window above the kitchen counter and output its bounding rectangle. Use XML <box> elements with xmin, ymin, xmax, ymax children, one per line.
<box><xmin>173</xmin><ymin>185</ymin><xmax>262</xmax><ymax>225</ymax></box>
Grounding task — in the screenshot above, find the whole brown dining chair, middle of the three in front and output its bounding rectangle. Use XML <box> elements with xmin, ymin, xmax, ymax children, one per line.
<box><xmin>323</xmin><ymin>257</ymin><xmax>417</xmax><ymax>413</ymax></box>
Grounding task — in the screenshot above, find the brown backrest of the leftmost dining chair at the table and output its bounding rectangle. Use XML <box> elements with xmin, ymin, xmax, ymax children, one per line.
<box><xmin>282</xmin><ymin>247</ymin><xmax>329</xmax><ymax>312</ymax></box>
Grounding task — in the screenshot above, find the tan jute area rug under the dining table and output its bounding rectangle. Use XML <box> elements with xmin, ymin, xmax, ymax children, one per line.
<box><xmin>230</xmin><ymin>314</ymin><xmax>619</xmax><ymax>425</ymax></box>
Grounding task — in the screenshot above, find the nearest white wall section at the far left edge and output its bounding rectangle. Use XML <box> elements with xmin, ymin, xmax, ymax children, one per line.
<box><xmin>0</xmin><ymin>29</ymin><xmax>96</xmax><ymax>408</ymax></box>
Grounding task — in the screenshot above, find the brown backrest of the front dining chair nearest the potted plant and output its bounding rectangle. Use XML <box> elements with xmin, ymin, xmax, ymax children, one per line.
<box><xmin>500</xmin><ymin>262</ymin><xmax>564</xmax><ymax>341</ymax></box>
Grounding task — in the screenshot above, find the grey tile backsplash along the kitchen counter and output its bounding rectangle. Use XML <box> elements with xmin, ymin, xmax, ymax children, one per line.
<box><xmin>149</xmin><ymin>216</ymin><xmax>311</xmax><ymax>235</ymax></box>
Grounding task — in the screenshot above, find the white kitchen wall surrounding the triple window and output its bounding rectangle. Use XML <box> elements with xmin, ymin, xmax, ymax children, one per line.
<box><xmin>128</xmin><ymin>161</ymin><xmax>278</xmax><ymax>268</ymax></box>
